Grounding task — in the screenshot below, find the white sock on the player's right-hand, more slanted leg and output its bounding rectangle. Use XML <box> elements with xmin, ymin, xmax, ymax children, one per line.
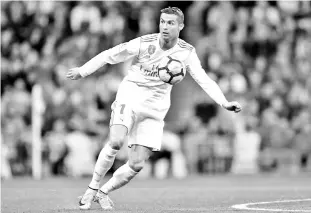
<box><xmin>100</xmin><ymin>162</ymin><xmax>138</xmax><ymax>194</ymax></box>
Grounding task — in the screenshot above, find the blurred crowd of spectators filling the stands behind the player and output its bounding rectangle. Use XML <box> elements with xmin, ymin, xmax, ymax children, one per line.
<box><xmin>1</xmin><ymin>1</ymin><xmax>311</xmax><ymax>179</ymax></box>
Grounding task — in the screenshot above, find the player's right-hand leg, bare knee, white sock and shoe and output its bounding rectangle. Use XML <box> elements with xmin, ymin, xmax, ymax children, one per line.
<box><xmin>96</xmin><ymin>145</ymin><xmax>152</xmax><ymax>210</ymax></box>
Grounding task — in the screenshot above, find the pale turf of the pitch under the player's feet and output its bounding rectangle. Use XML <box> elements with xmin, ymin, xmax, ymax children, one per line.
<box><xmin>1</xmin><ymin>174</ymin><xmax>311</xmax><ymax>213</ymax></box>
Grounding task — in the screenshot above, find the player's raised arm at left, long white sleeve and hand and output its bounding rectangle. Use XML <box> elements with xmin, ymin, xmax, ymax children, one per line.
<box><xmin>66</xmin><ymin>38</ymin><xmax>140</xmax><ymax>80</ymax></box>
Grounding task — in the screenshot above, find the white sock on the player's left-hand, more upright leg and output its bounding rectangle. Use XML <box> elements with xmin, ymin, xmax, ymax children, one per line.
<box><xmin>89</xmin><ymin>143</ymin><xmax>119</xmax><ymax>189</ymax></box>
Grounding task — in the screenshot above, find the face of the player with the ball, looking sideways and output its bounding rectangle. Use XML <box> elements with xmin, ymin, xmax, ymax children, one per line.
<box><xmin>159</xmin><ymin>13</ymin><xmax>183</xmax><ymax>40</ymax></box>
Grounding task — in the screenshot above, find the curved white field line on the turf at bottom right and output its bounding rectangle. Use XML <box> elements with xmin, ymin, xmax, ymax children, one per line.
<box><xmin>231</xmin><ymin>198</ymin><xmax>311</xmax><ymax>212</ymax></box>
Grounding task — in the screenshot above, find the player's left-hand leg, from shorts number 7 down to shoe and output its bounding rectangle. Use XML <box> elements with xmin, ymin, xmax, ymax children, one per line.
<box><xmin>79</xmin><ymin>104</ymin><xmax>133</xmax><ymax>209</ymax></box>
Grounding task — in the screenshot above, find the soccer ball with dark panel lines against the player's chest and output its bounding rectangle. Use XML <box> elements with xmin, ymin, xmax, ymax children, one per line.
<box><xmin>158</xmin><ymin>56</ymin><xmax>186</xmax><ymax>85</ymax></box>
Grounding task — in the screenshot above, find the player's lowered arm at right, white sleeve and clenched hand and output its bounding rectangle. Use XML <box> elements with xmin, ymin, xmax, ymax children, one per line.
<box><xmin>186</xmin><ymin>49</ymin><xmax>242</xmax><ymax>113</ymax></box>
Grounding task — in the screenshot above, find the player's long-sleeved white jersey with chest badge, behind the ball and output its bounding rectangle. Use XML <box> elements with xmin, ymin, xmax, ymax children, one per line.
<box><xmin>81</xmin><ymin>33</ymin><xmax>226</xmax><ymax>119</ymax></box>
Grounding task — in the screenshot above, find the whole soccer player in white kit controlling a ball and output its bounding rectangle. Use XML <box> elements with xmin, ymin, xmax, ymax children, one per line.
<box><xmin>66</xmin><ymin>7</ymin><xmax>241</xmax><ymax>210</ymax></box>
